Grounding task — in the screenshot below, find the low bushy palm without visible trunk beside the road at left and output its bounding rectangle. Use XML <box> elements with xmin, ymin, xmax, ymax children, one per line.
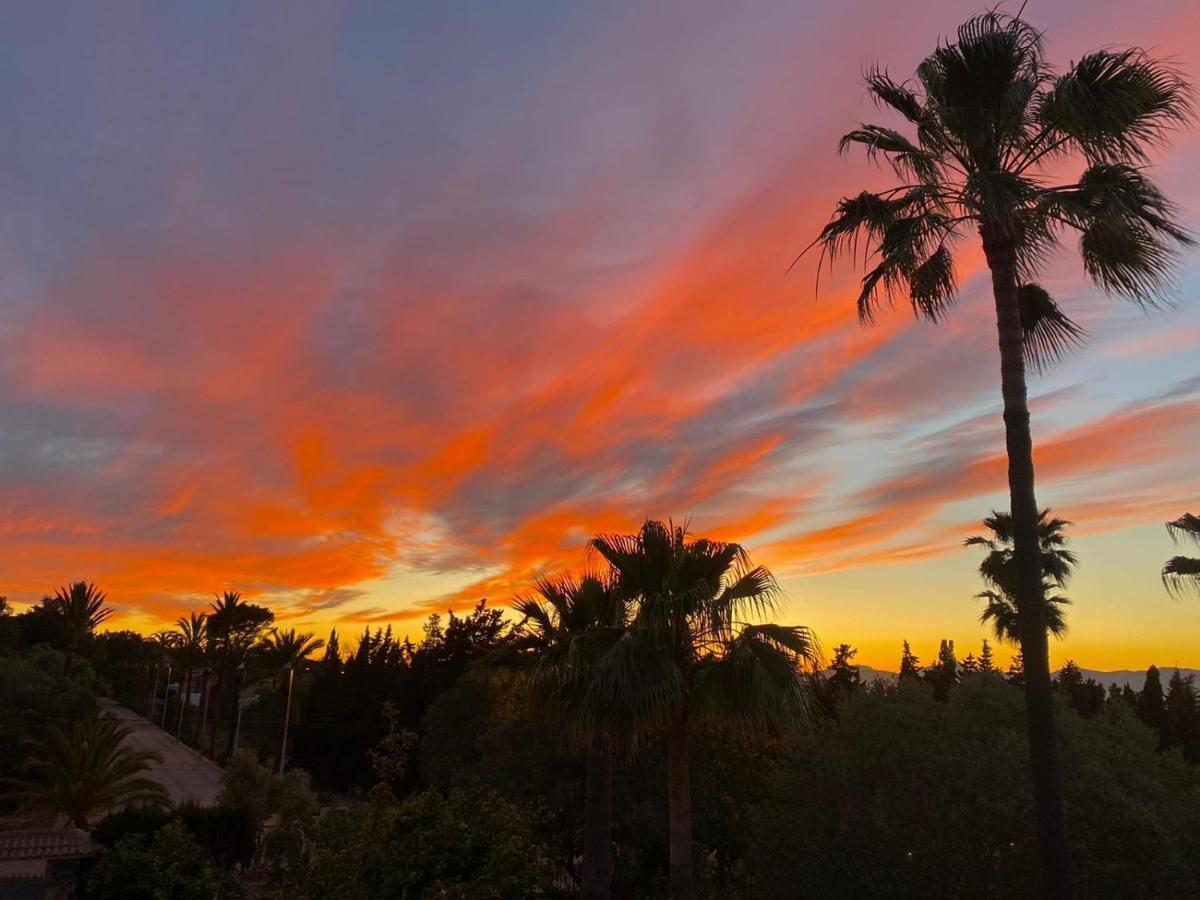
<box><xmin>7</xmin><ymin>718</ymin><xmax>169</xmax><ymax>828</ymax></box>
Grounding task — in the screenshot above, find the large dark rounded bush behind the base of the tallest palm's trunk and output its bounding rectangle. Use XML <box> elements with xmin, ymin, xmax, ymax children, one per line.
<box><xmin>726</xmin><ymin>676</ymin><xmax>1200</xmax><ymax>898</ymax></box>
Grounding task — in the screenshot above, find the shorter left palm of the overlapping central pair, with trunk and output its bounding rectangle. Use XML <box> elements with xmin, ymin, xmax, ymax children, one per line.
<box><xmin>512</xmin><ymin>575</ymin><xmax>626</xmax><ymax>900</ymax></box>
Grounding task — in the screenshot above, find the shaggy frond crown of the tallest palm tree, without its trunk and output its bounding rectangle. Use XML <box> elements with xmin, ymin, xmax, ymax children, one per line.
<box><xmin>814</xmin><ymin>12</ymin><xmax>1192</xmax><ymax>366</ymax></box>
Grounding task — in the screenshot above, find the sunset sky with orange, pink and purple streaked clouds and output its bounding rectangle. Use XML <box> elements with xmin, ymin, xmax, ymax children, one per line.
<box><xmin>0</xmin><ymin>0</ymin><xmax>1200</xmax><ymax>668</ymax></box>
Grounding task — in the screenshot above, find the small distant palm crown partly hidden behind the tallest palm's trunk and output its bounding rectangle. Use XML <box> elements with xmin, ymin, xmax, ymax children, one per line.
<box><xmin>964</xmin><ymin>509</ymin><xmax>1079</xmax><ymax>643</ymax></box>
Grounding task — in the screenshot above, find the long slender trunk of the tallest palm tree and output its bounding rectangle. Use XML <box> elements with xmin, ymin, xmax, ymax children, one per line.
<box><xmin>983</xmin><ymin>228</ymin><xmax>1073</xmax><ymax>898</ymax></box>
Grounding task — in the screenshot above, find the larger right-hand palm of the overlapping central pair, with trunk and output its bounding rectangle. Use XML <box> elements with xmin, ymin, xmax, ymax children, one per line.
<box><xmin>589</xmin><ymin>522</ymin><xmax>820</xmax><ymax>900</ymax></box>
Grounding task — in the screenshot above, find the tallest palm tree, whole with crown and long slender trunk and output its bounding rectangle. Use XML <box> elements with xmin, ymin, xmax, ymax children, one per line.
<box><xmin>814</xmin><ymin>11</ymin><xmax>1192</xmax><ymax>896</ymax></box>
